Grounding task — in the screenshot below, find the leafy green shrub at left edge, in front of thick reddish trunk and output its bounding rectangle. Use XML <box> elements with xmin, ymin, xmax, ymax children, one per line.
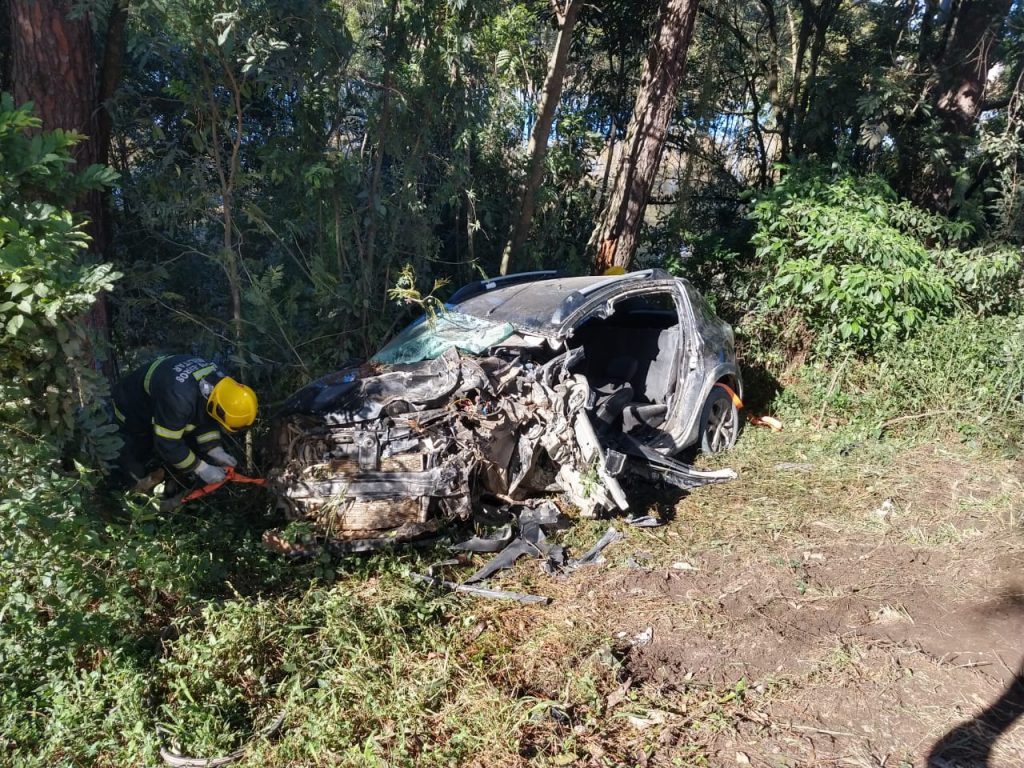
<box><xmin>0</xmin><ymin>93</ymin><xmax>119</xmax><ymax>456</ymax></box>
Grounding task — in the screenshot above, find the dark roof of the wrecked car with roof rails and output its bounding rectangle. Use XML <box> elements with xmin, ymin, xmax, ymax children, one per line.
<box><xmin>451</xmin><ymin>269</ymin><xmax>671</xmax><ymax>336</ymax></box>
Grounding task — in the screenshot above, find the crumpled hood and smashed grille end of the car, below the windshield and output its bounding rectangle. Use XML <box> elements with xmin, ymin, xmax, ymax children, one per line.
<box><xmin>272</xmin><ymin>349</ymin><xmax>627</xmax><ymax>537</ymax></box>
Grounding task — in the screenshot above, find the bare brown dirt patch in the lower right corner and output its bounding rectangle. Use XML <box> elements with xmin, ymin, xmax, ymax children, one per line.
<box><xmin>605</xmin><ymin>541</ymin><xmax>1024</xmax><ymax>767</ymax></box>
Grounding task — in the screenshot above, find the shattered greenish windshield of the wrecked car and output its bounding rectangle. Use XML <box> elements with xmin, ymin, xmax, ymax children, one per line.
<box><xmin>373</xmin><ymin>311</ymin><xmax>515</xmax><ymax>366</ymax></box>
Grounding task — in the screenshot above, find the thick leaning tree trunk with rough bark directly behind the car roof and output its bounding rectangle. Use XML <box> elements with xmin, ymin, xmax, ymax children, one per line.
<box><xmin>594</xmin><ymin>0</ymin><xmax>697</xmax><ymax>272</ymax></box>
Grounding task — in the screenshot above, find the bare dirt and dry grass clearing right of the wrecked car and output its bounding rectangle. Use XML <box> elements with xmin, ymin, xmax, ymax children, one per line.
<box><xmin>475</xmin><ymin>443</ymin><xmax>1024</xmax><ymax>768</ymax></box>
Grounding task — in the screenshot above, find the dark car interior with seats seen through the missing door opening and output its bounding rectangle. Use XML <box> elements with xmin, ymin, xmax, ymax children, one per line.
<box><xmin>569</xmin><ymin>292</ymin><xmax>685</xmax><ymax>440</ymax></box>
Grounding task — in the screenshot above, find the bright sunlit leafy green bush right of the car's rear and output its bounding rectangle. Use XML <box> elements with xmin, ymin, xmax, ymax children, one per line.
<box><xmin>752</xmin><ymin>170</ymin><xmax>1022</xmax><ymax>350</ymax></box>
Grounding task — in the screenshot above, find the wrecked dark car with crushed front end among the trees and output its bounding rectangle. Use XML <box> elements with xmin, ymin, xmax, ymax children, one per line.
<box><xmin>270</xmin><ymin>269</ymin><xmax>742</xmax><ymax>541</ymax></box>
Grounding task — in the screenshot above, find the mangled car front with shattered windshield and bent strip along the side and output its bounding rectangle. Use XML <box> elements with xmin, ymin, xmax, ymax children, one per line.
<box><xmin>271</xmin><ymin>274</ymin><xmax>733</xmax><ymax>542</ymax></box>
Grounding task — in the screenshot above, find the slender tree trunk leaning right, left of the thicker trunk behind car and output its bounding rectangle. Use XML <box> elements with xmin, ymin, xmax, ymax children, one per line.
<box><xmin>501</xmin><ymin>0</ymin><xmax>583</xmax><ymax>274</ymax></box>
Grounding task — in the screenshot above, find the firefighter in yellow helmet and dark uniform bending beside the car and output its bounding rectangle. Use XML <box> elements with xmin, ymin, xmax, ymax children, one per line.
<box><xmin>112</xmin><ymin>354</ymin><xmax>257</xmax><ymax>490</ymax></box>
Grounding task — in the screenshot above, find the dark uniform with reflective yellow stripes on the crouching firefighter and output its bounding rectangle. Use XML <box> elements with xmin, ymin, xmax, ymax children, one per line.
<box><xmin>113</xmin><ymin>354</ymin><xmax>224</xmax><ymax>482</ymax></box>
